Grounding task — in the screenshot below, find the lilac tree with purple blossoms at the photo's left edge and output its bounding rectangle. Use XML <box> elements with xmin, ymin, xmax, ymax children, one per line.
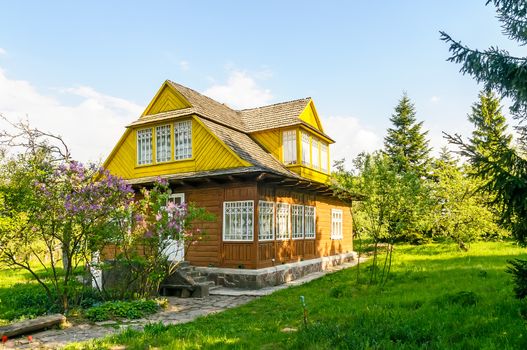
<box><xmin>0</xmin><ymin>149</ymin><xmax>133</xmax><ymax>312</ymax></box>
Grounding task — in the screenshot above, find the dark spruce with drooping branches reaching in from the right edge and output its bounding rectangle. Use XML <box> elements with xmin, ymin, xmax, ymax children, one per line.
<box><xmin>441</xmin><ymin>0</ymin><xmax>527</xmax><ymax>244</ymax></box>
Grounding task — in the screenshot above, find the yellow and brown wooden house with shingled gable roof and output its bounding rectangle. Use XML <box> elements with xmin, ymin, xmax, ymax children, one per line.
<box><xmin>104</xmin><ymin>81</ymin><xmax>353</xmax><ymax>286</ymax></box>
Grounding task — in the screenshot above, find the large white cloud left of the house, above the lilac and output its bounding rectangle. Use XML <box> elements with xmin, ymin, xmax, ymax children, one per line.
<box><xmin>0</xmin><ymin>68</ymin><xmax>143</xmax><ymax>162</ymax></box>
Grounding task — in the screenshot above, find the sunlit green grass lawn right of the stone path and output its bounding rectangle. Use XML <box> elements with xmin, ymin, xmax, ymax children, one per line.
<box><xmin>70</xmin><ymin>243</ymin><xmax>527</xmax><ymax>349</ymax></box>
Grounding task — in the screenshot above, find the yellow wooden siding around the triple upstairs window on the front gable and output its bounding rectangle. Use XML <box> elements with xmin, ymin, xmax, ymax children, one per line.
<box><xmin>106</xmin><ymin>119</ymin><xmax>249</xmax><ymax>179</ymax></box>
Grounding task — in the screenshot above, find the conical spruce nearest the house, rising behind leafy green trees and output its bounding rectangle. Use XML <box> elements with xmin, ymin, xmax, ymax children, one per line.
<box><xmin>384</xmin><ymin>93</ymin><xmax>430</xmax><ymax>177</ymax></box>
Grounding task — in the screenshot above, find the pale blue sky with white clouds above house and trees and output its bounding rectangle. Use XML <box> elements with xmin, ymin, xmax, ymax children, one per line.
<box><xmin>0</xmin><ymin>0</ymin><xmax>517</xmax><ymax>167</ymax></box>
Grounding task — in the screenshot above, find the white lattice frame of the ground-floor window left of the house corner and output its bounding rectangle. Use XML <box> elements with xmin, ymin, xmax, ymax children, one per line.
<box><xmin>222</xmin><ymin>200</ymin><xmax>254</xmax><ymax>242</ymax></box>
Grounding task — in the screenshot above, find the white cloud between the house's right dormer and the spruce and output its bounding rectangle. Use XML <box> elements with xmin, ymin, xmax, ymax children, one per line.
<box><xmin>322</xmin><ymin>116</ymin><xmax>382</xmax><ymax>169</ymax></box>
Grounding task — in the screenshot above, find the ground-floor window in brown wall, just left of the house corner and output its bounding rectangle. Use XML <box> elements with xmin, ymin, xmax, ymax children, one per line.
<box><xmin>223</xmin><ymin>201</ymin><xmax>254</xmax><ymax>241</ymax></box>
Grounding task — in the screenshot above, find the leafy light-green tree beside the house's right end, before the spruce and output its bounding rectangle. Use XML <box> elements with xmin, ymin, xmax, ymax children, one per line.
<box><xmin>332</xmin><ymin>152</ymin><xmax>422</xmax><ymax>283</ymax></box>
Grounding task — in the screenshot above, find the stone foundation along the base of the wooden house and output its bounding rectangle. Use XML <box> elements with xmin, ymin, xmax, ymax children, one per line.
<box><xmin>195</xmin><ymin>252</ymin><xmax>356</xmax><ymax>289</ymax></box>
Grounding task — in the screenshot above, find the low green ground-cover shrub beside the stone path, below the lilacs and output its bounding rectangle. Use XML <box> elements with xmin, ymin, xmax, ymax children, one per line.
<box><xmin>84</xmin><ymin>300</ymin><xmax>159</xmax><ymax>322</ymax></box>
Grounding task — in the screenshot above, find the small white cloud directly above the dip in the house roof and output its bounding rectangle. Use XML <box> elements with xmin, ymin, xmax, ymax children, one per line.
<box><xmin>203</xmin><ymin>70</ymin><xmax>273</xmax><ymax>109</ymax></box>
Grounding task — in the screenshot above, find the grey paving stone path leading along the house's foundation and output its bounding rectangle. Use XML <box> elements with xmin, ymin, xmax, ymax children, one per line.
<box><xmin>0</xmin><ymin>259</ymin><xmax>362</xmax><ymax>349</ymax></box>
